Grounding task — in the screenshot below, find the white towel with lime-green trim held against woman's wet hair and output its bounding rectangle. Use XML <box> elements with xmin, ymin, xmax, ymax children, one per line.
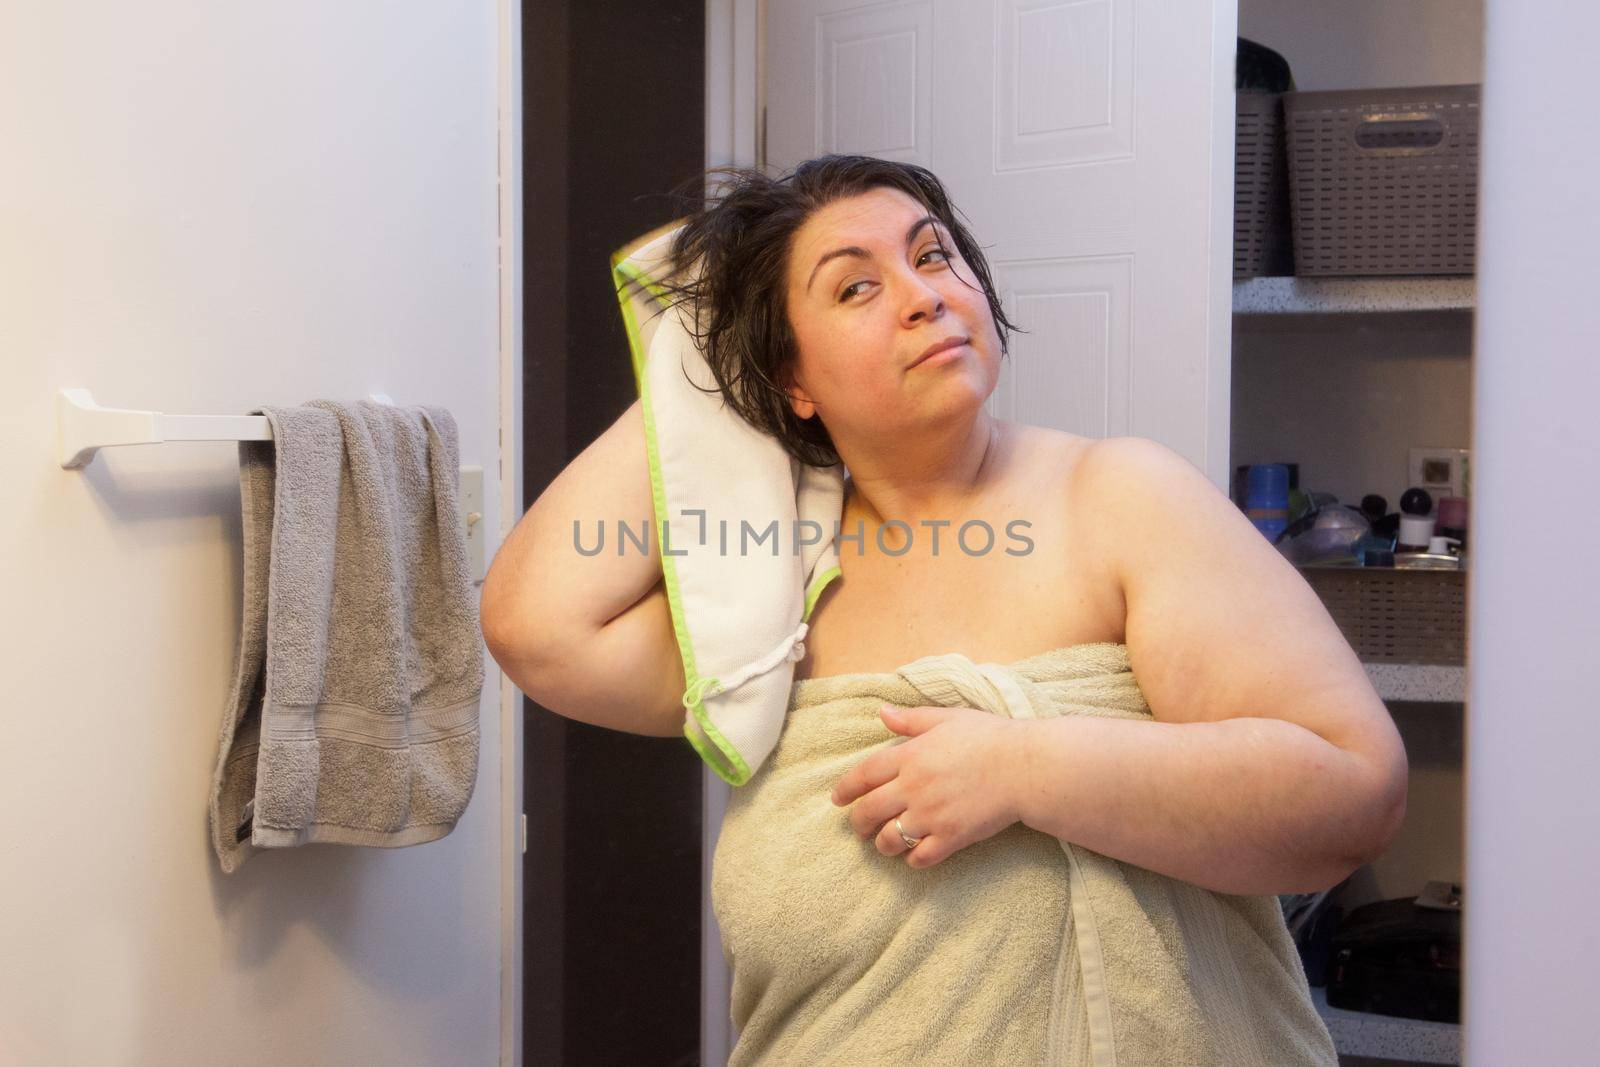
<box><xmin>611</xmin><ymin>221</ymin><xmax>845</xmax><ymax>785</ymax></box>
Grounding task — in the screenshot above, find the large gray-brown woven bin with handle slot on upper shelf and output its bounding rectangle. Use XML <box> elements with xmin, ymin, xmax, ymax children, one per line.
<box><xmin>1283</xmin><ymin>85</ymin><xmax>1478</xmax><ymax>275</ymax></box>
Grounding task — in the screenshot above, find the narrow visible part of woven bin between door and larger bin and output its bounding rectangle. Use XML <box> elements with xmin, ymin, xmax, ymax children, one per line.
<box><xmin>1234</xmin><ymin>91</ymin><xmax>1294</xmax><ymax>278</ymax></box>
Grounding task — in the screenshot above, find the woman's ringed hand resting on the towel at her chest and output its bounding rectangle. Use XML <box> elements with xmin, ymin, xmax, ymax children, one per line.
<box><xmin>834</xmin><ymin>704</ymin><xmax>1026</xmax><ymax>867</ymax></box>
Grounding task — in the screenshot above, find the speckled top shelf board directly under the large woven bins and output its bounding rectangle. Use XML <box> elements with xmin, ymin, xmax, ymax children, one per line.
<box><xmin>1234</xmin><ymin>275</ymin><xmax>1477</xmax><ymax>315</ymax></box>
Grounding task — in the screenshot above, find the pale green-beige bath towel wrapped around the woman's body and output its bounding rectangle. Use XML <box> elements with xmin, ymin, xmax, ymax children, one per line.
<box><xmin>712</xmin><ymin>643</ymin><xmax>1338</xmax><ymax>1067</ymax></box>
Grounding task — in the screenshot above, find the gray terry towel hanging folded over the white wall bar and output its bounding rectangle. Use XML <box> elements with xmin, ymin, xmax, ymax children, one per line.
<box><xmin>210</xmin><ymin>400</ymin><xmax>483</xmax><ymax>873</ymax></box>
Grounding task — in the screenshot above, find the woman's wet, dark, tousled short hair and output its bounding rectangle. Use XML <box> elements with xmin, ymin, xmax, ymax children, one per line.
<box><xmin>643</xmin><ymin>155</ymin><xmax>1016</xmax><ymax>467</ymax></box>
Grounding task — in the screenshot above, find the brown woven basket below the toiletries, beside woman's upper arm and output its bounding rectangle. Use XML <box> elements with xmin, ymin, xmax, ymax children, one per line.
<box><xmin>1301</xmin><ymin>566</ymin><xmax>1467</xmax><ymax>665</ymax></box>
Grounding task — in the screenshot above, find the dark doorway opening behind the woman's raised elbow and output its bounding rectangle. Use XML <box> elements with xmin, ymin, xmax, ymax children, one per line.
<box><xmin>522</xmin><ymin>0</ymin><xmax>706</xmax><ymax>1067</ymax></box>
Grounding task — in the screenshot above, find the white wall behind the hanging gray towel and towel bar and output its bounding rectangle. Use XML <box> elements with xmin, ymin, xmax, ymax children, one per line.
<box><xmin>0</xmin><ymin>0</ymin><xmax>502</xmax><ymax>1064</ymax></box>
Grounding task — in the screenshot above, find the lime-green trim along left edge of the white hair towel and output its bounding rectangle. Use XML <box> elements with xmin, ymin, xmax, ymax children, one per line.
<box><xmin>611</xmin><ymin>244</ymin><xmax>752</xmax><ymax>785</ymax></box>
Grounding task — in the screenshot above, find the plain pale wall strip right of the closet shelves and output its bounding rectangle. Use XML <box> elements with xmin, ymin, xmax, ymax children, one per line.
<box><xmin>1462</xmin><ymin>0</ymin><xmax>1600</xmax><ymax>1067</ymax></box>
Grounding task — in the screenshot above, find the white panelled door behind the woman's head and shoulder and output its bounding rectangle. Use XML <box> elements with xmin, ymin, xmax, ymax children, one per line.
<box><xmin>763</xmin><ymin>0</ymin><xmax>1237</xmax><ymax>488</ymax></box>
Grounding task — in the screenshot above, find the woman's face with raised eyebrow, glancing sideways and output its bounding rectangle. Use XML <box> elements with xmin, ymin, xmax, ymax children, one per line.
<box><xmin>786</xmin><ymin>187</ymin><xmax>1000</xmax><ymax>442</ymax></box>
